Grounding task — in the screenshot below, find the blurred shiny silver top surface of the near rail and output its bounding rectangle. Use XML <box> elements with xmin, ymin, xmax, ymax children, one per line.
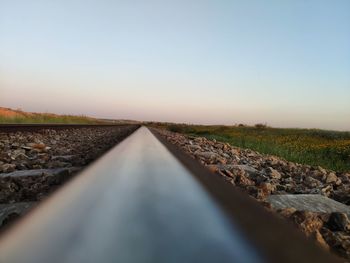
<box><xmin>0</xmin><ymin>127</ymin><xmax>264</xmax><ymax>263</ymax></box>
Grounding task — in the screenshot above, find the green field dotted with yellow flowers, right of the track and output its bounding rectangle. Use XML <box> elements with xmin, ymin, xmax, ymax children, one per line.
<box><xmin>154</xmin><ymin>124</ymin><xmax>350</xmax><ymax>172</ymax></box>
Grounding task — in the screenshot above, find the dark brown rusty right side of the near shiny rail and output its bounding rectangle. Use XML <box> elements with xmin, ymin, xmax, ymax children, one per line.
<box><xmin>150</xmin><ymin>128</ymin><xmax>343</xmax><ymax>263</ymax></box>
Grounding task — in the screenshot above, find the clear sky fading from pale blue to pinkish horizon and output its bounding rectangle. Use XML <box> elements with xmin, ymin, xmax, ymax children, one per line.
<box><xmin>0</xmin><ymin>0</ymin><xmax>350</xmax><ymax>130</ymax></box>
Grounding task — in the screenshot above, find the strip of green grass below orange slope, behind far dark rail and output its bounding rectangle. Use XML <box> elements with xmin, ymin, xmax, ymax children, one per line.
<box><xmin>0</xmin><ymin>114</ymin><xmax>102</xmax><ymax>124</ymax></box>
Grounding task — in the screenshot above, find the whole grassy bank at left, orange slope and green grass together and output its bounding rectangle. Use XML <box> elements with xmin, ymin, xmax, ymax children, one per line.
<box><xmin>0</xmin><ymin>107</ymin><xmax>103</xmax><ymax>124</ymax></box>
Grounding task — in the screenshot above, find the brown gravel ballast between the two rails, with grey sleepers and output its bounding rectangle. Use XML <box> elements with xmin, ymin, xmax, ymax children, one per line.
<box><xmin>0</xmin><ymin>125</ymin><xmax>139</xmax><ymax>229</ymax></box>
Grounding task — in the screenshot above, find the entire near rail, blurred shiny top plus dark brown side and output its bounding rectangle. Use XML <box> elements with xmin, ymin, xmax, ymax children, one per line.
<box><xmin>0</xmin><ymin>127</ymin><xmax>340</xmax><ymax>263</ymax></box>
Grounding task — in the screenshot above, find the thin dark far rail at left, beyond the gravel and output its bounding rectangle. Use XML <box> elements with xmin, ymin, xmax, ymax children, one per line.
<box><xmin>0</xmin><ymin>123</ymin><xmax>133</xmax><ymax>133</ymax></box>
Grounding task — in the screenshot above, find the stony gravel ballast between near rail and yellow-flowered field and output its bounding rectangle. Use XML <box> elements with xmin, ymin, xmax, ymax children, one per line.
<box><xmin>157</xmin><ymin>129</ymin><xmax>350</xmax><ymax>260</ymax></box>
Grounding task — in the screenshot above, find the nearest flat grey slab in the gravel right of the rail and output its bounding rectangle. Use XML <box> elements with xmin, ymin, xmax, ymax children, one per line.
<box><xmin>267</xmin><ymin>194</ymin><xmax>350</xmax><ymax>216</ymax></box>
